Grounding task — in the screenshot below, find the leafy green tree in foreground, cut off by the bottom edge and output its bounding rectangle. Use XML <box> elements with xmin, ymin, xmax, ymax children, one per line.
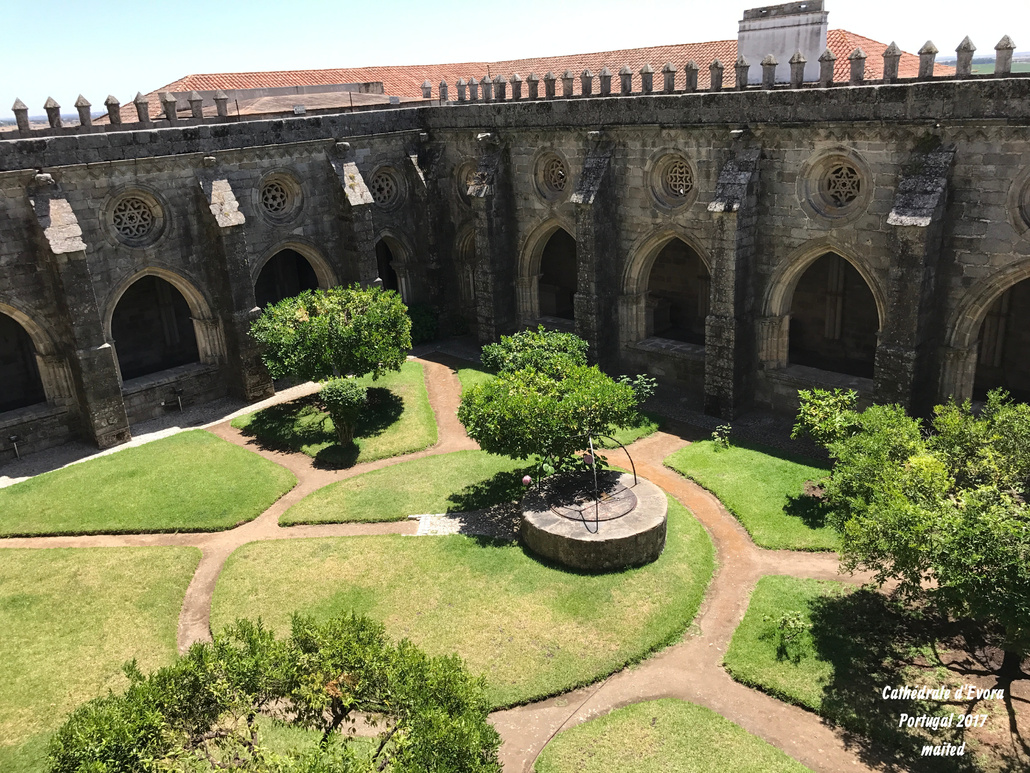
<box><xmin>47</xmin><ymin>615</ymin><xmax>501</xmax><ymax>773</ymax></box>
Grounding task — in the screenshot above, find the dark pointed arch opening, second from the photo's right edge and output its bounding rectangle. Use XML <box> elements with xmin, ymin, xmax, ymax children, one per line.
<box><xmin>789</xmin><ymin>254</ymin><xmax>880</xmax><ymax>378</ymax></box>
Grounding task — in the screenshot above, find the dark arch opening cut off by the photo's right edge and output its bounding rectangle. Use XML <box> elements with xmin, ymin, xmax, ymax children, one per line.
<box><xmin>973</xmin><ymin>279</ymin><xmax>1030</xmax><ymax>403</ymax></box>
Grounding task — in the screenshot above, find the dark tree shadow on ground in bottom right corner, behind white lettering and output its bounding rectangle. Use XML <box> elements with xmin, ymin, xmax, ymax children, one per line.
<box><xmin>810</xmin><ymin>590</ymin><xmax>980</xmax><ymax>773</ymax></box>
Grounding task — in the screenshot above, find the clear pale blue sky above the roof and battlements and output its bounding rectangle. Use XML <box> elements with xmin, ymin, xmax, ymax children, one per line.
<box><xmin>0</xmin><ymin>0</ymin><xmax>1030</xmax><ymax>119</ymax></box>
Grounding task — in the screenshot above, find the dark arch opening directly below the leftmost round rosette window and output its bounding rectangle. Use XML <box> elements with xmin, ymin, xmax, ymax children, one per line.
<box><xmin>111</xmin><ymin>276</ymin><xmax>200</xmax><ymax>380</ymax></box>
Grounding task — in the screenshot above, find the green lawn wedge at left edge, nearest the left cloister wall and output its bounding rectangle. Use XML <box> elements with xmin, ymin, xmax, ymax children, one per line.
<box><xmin>0</xmin><ymin>430</ymin><xmax>297</xmax><ymax>537</ymax></box>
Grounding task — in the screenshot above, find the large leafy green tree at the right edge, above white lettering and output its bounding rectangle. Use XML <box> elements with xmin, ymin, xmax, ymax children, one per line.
<box><xmin>798</xmin><ymin>391</ymin><xmax>1030</xmax><ymax>677</ymax></box>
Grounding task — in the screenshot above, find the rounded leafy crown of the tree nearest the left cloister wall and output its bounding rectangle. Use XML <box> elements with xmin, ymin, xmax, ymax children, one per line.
<box><xmin>250</xmin><ymin>284</ymin><xmax>411</xmax><ymax>381</ymax></box>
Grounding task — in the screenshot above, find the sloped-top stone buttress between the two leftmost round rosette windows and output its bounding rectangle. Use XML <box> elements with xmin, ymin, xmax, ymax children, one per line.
<box><xmin>197</xmin><ymin>166</ymin><xmax>275</xmax><ymax>401</ymax></box>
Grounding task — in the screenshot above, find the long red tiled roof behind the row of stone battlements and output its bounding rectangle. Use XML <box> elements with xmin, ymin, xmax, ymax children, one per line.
<box><xmin>116</xmin><ymin>30</ymin><xmax>955</xmax><ymax>121</ymax></box>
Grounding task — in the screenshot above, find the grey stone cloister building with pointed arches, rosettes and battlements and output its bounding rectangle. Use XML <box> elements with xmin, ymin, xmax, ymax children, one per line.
<box><xmin>0</xmin><ymin>4</ymin><xmax>1030</xmax><ymax>459</ymax></box>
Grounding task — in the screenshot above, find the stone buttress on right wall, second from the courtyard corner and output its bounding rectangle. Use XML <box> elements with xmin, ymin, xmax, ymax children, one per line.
<box><xmin>571</xmin><ymin>135</ymin><xmax>619</xmax><ymax>368</ymax></box>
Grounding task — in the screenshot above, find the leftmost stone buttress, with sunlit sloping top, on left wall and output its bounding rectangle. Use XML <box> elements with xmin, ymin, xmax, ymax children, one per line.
<box><xmin>29</xmin><ymin>174</ymin><xmax>132</xmax><ymax>448</ymax></box>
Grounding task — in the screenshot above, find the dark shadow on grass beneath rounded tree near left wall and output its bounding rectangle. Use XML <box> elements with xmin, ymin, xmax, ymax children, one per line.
<box><xmin>241</xmin><ymin>387</ymin><xmax>404</xmax><ymax>470</ymax></box>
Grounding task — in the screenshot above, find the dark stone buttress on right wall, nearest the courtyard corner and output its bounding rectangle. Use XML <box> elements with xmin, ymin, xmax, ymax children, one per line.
<box><xmin>469</xmin><ymin>133</ymin><xmax>515</xmax><ymax>343</ymax></box>
